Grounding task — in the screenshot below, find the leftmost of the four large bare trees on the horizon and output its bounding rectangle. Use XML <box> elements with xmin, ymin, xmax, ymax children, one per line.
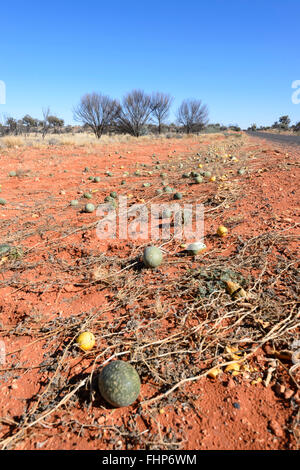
<box><xmin>74</xmin><ymin>93</ymin><xmax>120</xmax><ymax>139</ymax></box>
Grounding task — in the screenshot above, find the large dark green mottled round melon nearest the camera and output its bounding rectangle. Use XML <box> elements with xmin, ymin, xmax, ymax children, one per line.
<box><xmin>98</xmin><ymin>361</ymin><xmax>141</xmax><ymax>408</ymax></box>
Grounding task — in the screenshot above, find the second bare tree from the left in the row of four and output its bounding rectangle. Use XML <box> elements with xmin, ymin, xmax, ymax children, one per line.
<box><xmin>117</xmin><ymin>90</ymin><xmax>153</xmax><ymax>137</ymax></box>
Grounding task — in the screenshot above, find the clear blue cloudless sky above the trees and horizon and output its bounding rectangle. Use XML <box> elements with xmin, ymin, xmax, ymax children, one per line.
<box><xmin>0</xmin><ymin>0</ymin><xmax>300</xmax><ymax>128</ymax></box>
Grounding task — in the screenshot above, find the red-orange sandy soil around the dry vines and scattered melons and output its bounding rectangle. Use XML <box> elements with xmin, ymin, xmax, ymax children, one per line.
<box><xmin>0</xmin><ymin>135</ymin><xmax>300</xmax><ymax>450</ymax></box>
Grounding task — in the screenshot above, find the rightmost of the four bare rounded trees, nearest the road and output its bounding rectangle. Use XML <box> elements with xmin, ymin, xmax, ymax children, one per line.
<box><xmin>177</xmin><ymin>99</ymin><xmax>208</xmax><ymax>134</ymax></box>
